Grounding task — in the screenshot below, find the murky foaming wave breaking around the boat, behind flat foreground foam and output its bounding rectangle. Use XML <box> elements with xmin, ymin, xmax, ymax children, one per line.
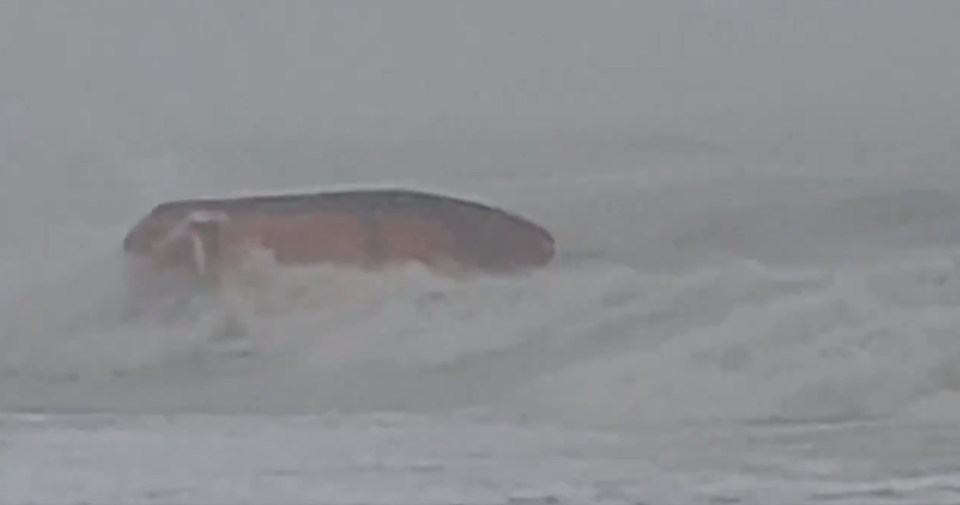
<box><xmin>0</xmin><ymin>153</ymin><xmax>960</xmax><ymax>428</ymax></box>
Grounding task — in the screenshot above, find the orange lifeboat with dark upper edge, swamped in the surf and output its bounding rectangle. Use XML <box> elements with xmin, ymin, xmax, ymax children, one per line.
<box><xmin>123</xmin><ymin>189</ymin><xmax>554</xmax><ymax>286</ymax></box>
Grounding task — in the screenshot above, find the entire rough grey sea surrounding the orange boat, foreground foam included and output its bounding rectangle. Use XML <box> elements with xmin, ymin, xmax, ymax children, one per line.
<box><xmin>0</xmin><ymin>148</ymin><xmax>960</xmax><ymax>504</ymax></box>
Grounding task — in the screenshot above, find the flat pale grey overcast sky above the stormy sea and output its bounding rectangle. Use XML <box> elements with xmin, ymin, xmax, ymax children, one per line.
<box><xmin>0</xmin><ymin>0</ymin><xmax>960</xmax><ymax>152</ymax></box>
